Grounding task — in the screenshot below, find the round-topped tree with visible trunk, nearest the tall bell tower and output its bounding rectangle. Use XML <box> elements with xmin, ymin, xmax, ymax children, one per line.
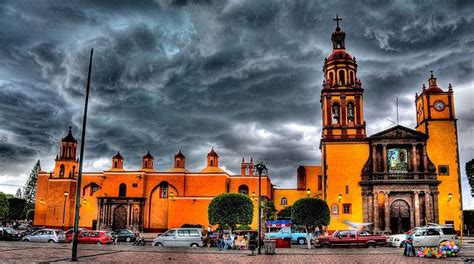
<box><xmin>291</xmin><ymin>198</ymin><xmax>330</xmax><ymax>249</ymax></box>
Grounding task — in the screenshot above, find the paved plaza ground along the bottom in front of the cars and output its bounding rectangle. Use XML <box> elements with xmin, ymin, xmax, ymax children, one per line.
<box><xmin>0</xmin><ymin>242</ymin><xmax>474</xmax><ymax>264</ymax></box>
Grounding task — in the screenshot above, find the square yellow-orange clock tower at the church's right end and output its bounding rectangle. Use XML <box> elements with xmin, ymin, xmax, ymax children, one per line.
<box><xmin>415</xmin><ymin>72</ymin><xmax>462</xmax><ymax>229</ymax></box>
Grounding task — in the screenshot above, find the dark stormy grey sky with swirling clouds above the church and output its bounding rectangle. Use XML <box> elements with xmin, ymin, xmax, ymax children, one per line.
<box><xmin>0</xmin><ymin>0</ymin><xmax>474</xmax><ymax>208</ymax></box>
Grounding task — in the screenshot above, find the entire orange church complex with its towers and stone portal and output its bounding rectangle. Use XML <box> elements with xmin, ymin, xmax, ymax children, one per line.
<box><xmin>34</xmin><ymin>17</ymin><xmax>462</xmax><ymax>233</ymax></box>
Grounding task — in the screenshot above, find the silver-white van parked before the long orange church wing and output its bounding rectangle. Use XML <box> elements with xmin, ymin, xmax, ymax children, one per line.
<box><xmin>153</xmin><ymin>228</ymin><xmax>204</xmax><ymax>247</ymax></box>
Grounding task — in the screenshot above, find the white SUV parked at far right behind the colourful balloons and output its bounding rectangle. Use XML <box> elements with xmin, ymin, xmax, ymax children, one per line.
<box><xmin>388</xmin><ymin>224</ymin><xmax>458</xmax><ymax>247</ymax></box>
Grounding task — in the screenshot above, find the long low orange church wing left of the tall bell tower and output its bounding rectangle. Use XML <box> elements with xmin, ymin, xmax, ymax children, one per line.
<box><xmin>35</xmin><ymin>129</ymin><xmax>322</xmax><ymax>231</ymax></box>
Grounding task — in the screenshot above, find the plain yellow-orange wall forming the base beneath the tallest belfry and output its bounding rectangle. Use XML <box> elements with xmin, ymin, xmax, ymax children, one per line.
<box><xmin>322</xmin><ymin>142</ymin><xmax>369</xmax><ymax>231</ymax></box>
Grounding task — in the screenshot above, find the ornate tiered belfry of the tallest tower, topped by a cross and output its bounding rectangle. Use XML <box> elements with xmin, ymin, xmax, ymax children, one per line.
<box><xmin>321</xmin><ymin>15</ymin><xmax>366</xmax><ymax>141</ymax></box>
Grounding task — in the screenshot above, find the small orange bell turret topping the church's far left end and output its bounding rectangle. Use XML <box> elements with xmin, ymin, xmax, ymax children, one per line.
<box><xmin>51</xmin><ymin>127</ymin><xmax>78</xmax><ymax>179</ymax></box>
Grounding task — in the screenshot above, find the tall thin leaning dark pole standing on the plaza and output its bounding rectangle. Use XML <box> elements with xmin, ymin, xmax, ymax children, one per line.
<box><xmin>71</xmin><ymin>49</ymin><xmax>94</xmax><ymax>261</ymax></box>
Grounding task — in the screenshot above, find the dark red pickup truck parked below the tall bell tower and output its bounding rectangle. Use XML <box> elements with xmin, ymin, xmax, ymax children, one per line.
<box><xmin>314</xmin><ymin>230</ymin><xmax>387</xmax><ymax>247</ymax></box>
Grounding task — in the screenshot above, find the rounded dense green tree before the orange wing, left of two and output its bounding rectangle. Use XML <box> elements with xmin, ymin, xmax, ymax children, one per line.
<box><xmin>208</xmin><ymin>193</ymin><xmax>253</xmax><ymax>232</ymax></box>
